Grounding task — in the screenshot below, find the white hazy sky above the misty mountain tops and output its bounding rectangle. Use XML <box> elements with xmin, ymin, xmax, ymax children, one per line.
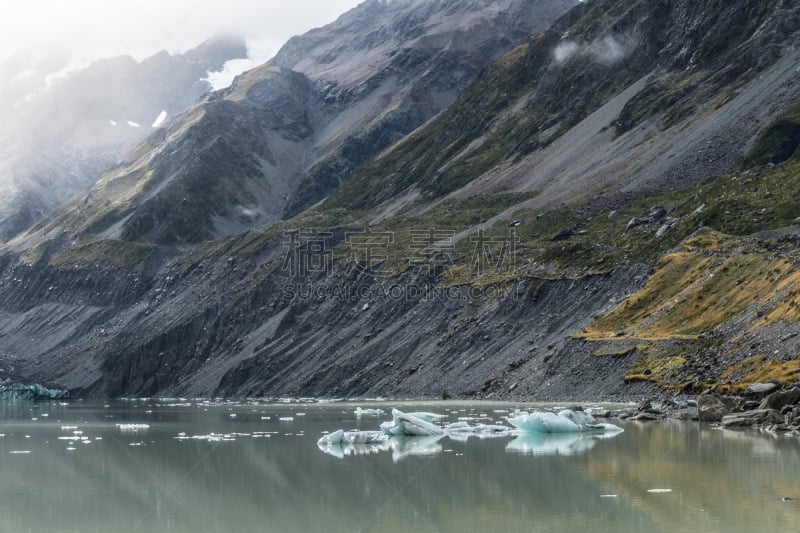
<box><xmin>0</xmin><ymin>0</ymin><xmax>361</xmax><ymax>63</ymax></box>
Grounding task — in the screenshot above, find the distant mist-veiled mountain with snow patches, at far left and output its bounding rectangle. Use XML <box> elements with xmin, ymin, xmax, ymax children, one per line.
<box><xmin>0</xmin><ymin>36</ymin><xmax>247</xmax><ymax>240</ymax></box>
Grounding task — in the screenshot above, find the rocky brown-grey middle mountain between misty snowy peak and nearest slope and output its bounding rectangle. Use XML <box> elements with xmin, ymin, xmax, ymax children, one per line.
<box><xmin>12</xmin><ymin>0</ymin><xmax>577</xmax><ymax>244</ymax></box>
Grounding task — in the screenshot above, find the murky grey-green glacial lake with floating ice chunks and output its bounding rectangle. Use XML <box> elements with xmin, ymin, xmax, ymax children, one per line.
<box><xmin>0</xmin><ymin>400</ymin><xmax>800</xmax><ymax>533</ymax></box>
